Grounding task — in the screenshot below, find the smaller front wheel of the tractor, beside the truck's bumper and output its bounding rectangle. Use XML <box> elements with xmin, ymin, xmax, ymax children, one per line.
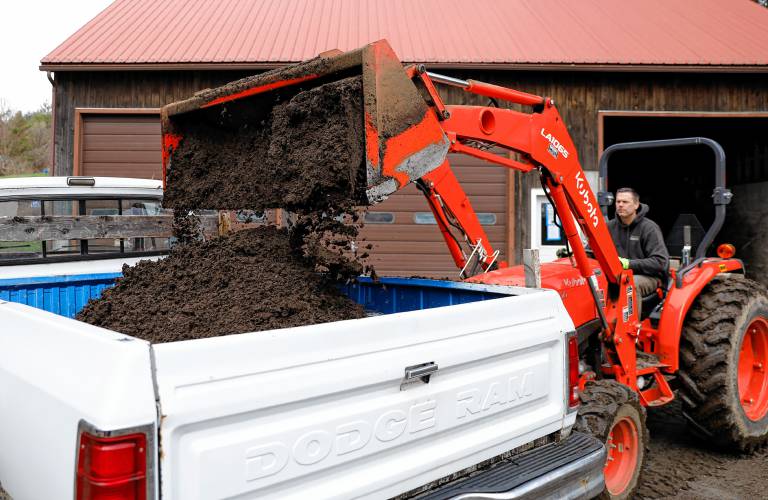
<box><xmin>574</xmin><ymin>380</ymin><xmax>648</xmax><ymax>500</ymax></box>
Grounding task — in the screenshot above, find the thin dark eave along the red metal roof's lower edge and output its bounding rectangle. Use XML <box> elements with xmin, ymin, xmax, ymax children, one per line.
<box><xmin>39</xmin><ymin>61</ymin><xmax>768</xmax><ymax>73</ymax></box>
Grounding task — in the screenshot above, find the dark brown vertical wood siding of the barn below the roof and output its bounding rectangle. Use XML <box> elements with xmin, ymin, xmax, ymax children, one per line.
<box><xmin>54</xmin><ymin>70</ymin><xmax>768</xmax><ymax>262</ymax></box>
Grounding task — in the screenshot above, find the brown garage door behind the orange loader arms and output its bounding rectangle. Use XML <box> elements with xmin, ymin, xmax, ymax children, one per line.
<box><xmin>362</xmin><ymin>155</ymin><xmax>508</xmax><ymax>277</ymax></box>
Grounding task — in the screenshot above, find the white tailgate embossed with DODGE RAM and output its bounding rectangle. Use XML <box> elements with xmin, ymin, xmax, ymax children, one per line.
<box><xmin>153</xmin><ymin>291</ymin><xmax>573</xmax><ymax>499</ymax></box>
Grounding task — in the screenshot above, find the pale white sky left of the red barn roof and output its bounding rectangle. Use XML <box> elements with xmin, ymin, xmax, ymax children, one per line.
<box><xmin>0</xmin><ymin>0</ymin><xmax>113</xmax><ymax>112</ymax></box>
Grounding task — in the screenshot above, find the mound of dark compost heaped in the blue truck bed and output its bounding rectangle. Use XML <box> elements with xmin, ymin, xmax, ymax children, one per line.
<box><xmin>77</xmin><ymin>226</ymin><xmax>365</xmax><ymax>343</ymax></box>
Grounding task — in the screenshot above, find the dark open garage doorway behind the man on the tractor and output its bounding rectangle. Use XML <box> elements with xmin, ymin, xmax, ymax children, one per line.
<box><xmin>601</xmin><ymin>113</ymin><xmax>768</xmax><ymax>282</ymax></box>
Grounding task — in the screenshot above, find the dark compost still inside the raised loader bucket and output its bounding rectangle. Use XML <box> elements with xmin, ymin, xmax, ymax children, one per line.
<box><xmin>164</xmin><ymin>77</ymin><xmax>366</xmax><ymax>211</ymax></box>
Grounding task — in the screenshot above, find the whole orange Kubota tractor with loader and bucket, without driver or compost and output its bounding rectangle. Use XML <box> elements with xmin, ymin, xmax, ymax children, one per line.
<box><xmin>162</xmin><ymin>41</ymin><xmax>768</xmax><ymax>498</ymax></box>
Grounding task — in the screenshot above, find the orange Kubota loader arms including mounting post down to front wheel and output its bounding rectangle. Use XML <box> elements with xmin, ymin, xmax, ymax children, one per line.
<box><xmin>407</xmin><ymin>70</ymin><xmax>662</xmax><ymax>392</ymax></box>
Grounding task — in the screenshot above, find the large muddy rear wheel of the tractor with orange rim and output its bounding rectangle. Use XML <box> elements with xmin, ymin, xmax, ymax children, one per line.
<box><xmin>678</xmin><ymin>274</ymin><xmax>768</xmax><ymax>452</ymax></box>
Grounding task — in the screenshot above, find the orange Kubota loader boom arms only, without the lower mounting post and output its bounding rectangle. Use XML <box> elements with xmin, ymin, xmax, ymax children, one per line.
<box><xmin>409</xmin><ymin>69</ymin><xmax>622</xmax><ymax>290</ymax></box>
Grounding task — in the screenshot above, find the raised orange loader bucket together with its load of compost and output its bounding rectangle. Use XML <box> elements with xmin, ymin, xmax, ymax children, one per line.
<box><xmin>161</xmin><ymin>40</ymin><xmax>449</xmax><ymax>209</ymax></box>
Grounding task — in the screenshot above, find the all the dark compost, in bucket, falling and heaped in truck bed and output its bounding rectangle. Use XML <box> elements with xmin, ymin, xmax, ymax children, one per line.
<box><xmin>78</xmin><ymin>77</ymin><xmax>376</xmax><ymax>342</ymax></box>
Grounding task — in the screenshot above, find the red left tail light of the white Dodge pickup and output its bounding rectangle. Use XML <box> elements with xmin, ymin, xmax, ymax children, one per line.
<box><xmin>76</xmin><ymin>432</ymin><xmax>147</xmax><ymax>500</ymax></box>
